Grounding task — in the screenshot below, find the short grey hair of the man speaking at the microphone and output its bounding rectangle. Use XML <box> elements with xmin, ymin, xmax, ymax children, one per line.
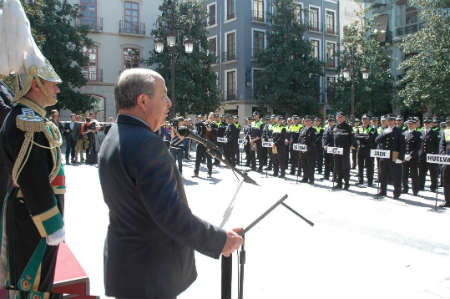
<box><xmin>114</xmin><ymin>68</ymin><xmax>162</xmax><ymax>110</ymax></box>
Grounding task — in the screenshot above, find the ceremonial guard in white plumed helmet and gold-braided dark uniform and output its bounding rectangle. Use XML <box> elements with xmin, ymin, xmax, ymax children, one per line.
<box><xmin>0</xmin><ymin>0</ymin><xmax>65</xmax><ymax>299</ymax></box>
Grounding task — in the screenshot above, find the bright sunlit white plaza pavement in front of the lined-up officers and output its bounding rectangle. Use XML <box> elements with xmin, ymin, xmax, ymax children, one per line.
<box><xmin>65</xmin><ymin>155</ymin><xmax>450</xmax><ymax>298</ymax></box>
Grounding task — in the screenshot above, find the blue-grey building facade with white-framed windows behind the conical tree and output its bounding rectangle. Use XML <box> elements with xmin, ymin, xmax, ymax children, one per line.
<box><xmin>207</xmin><ymin>0</ymin><xmax>341</xmax><ymax>120</ymax></box>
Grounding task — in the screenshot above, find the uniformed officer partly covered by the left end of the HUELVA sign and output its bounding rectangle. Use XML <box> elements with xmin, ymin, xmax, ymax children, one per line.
<box><xmin>419</xmin><ymin>118</ymin><xmax>439</xmax><ymax>192</ymax></box>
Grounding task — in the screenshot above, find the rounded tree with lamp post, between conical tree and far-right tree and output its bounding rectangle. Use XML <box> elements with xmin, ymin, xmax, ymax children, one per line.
<box><xmin>332</xmin><ymin>20</ymin><xmax>394</xmax><ymax>115</ymax></box>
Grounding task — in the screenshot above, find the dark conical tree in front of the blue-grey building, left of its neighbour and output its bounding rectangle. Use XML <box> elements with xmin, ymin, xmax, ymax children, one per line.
<box><xmin>255</xmin><ymin>0</ymin><xmax>322</xmax><ymax>114</ymax></box>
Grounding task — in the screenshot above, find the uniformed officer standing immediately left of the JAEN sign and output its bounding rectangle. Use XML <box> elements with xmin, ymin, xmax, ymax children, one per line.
<box><xmin>355</xmin><ymin>114</ymin><xmax>376</xmax><ymax>187</ymax></box>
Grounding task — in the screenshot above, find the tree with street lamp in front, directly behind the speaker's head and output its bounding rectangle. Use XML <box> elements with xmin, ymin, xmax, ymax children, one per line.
<box><xmin>147</xmin><ymin>0</ymin><xmax>220</xmax><ymax>114</ymax></box>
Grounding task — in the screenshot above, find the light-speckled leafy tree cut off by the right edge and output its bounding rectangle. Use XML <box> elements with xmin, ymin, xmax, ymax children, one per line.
<box><xmin>399</xmin><ymin>0</ymin><xmax>450</xmax><ymax>114</ymax></box>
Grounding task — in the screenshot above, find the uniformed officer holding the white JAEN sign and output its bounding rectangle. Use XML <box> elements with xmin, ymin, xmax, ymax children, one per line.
<box><xmin>375</xmin><ymin>115</ymin><xmax>405</xmax><ymax>199</ymax></box>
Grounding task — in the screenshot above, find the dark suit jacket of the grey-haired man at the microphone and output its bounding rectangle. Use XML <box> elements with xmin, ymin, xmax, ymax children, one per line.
<box><xmin>99</xmin><ymin>115</ymin><xmax>226</xmax><ymax>298</ymax></box>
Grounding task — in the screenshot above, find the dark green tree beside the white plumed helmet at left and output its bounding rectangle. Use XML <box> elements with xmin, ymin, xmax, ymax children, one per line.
<box><xmin>22</xmin><ymin>0</ymin><xmax>95</xmax><ymax>113</ymax></box>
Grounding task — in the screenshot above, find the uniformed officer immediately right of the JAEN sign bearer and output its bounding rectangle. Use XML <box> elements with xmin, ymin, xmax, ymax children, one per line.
<box><xmin>402</xmin><ymin>119</ymin><xmax>422</xmax><ymax>195</ymax></box>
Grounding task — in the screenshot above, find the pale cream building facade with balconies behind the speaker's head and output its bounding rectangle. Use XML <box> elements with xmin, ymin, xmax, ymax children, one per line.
<box><xmin>66</xmin><ymin>0</ymin><xmax>162</xmax><ymax>121</ymax></box>
